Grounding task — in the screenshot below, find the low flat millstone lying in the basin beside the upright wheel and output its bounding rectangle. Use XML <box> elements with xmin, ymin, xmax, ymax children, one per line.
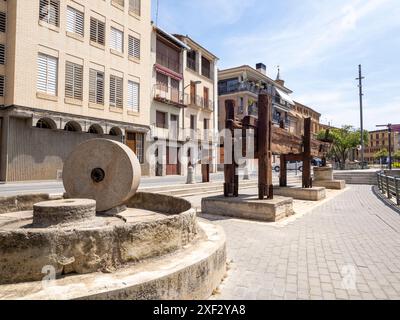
<box><xmin>33</xmin><ymin>199</ymin><xmax>96</xmax><ymax>227</ymax></box>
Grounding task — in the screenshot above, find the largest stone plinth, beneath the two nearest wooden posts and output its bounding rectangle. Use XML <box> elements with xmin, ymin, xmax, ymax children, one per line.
<box><xmin>201</xmin><ymin>195</ymin><xmax>294</xmax><ymax>222</ymax></box>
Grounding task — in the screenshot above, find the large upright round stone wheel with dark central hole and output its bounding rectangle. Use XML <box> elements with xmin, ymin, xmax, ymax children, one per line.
<box><xmin>63</xmin><ymin>139</ymin><xmax>141</xmax><ymax>212</ymax></box>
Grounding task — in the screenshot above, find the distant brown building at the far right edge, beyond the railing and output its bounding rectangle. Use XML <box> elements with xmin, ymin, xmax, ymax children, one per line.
<box><xmin>364</xmin><ymin>130</ymin><xmax>400</xmax><ymax>164</ymax></box>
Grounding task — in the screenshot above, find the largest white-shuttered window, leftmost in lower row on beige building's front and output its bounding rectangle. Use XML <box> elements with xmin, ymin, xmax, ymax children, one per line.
<box><xmin>37</xmin><ymin>53</ymin><xmax>58</xmax><ymax>96</ymax></box>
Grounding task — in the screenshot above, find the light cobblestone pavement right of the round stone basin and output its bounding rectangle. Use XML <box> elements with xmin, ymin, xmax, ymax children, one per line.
<box><xmin>205</xmin><ymin>186</ymin><xmax>400</xmax><ymax>300</ymax></box>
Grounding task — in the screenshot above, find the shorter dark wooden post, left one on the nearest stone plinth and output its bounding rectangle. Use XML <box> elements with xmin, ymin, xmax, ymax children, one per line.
<box><xmin>224</xmin><ymin>100</ymin><xmax>239</xmax><ymax>197</ymax></box>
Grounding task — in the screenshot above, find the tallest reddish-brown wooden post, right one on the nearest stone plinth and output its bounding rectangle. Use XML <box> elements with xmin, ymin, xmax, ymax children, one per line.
<box><xmin>257</xmin><ymin>94</ymin><xmax>274</xmax><ymax>200</ymax></box>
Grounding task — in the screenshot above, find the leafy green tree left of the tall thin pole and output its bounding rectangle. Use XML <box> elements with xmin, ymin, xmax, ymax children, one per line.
<box><xmin>318</xmin><ymin>125</ymin><xmax>369</xmax><ymax>170</ymax></box>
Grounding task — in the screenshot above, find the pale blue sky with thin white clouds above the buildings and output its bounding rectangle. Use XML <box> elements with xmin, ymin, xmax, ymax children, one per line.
<box><xmin>152</xmin><ymin>0</ymin><xmax>400</xmax><ymax>130</ymax></box>
